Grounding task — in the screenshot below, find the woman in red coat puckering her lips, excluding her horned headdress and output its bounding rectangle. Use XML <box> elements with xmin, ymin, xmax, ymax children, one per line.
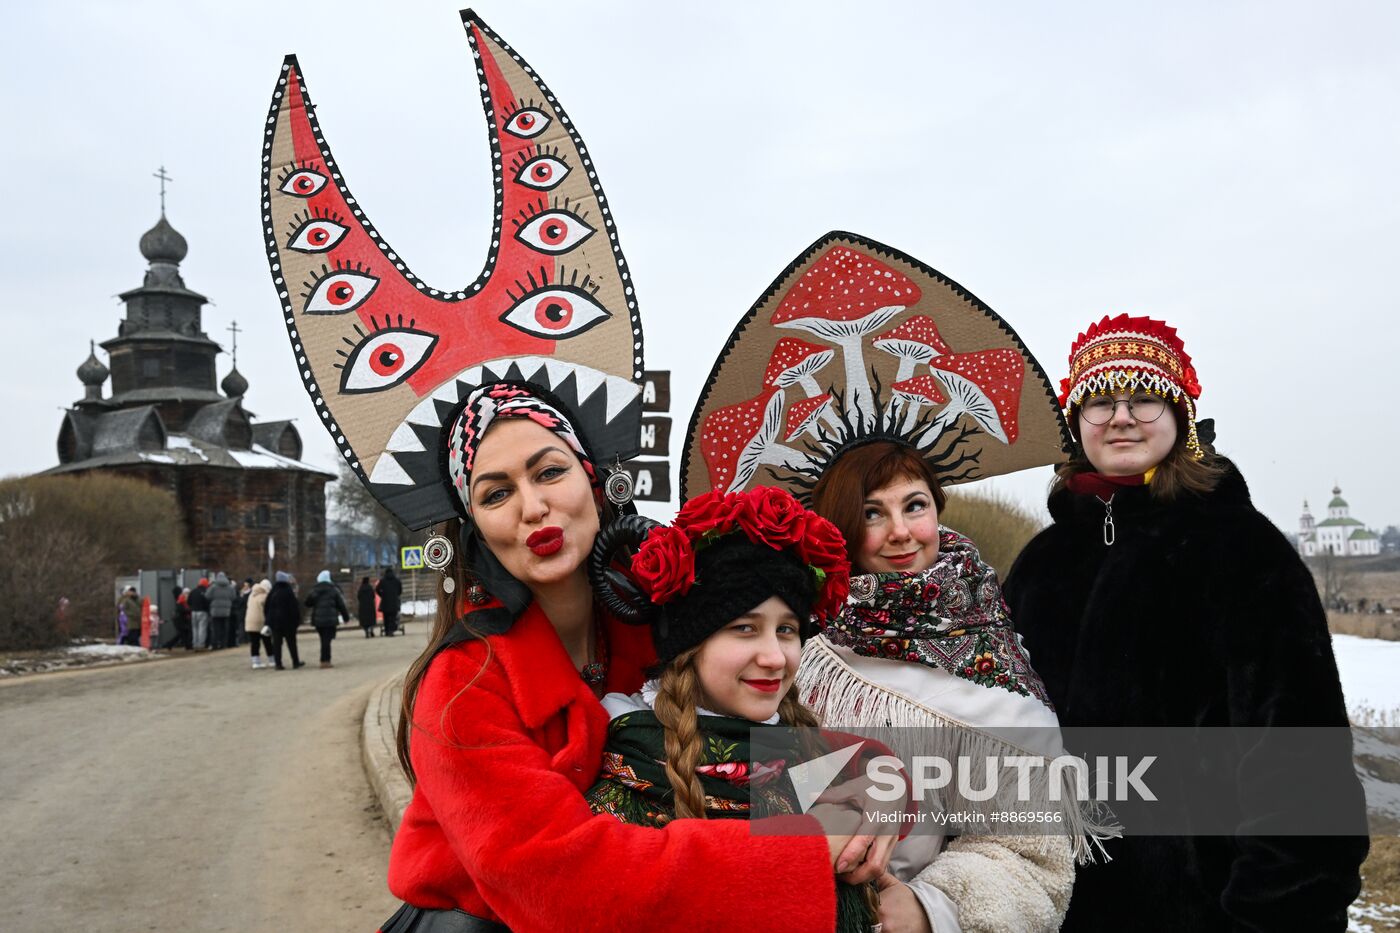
<box><xmin>381</xmin><ymin>384</ymin><xmax>888</xmax><ymax>933</ymax></box>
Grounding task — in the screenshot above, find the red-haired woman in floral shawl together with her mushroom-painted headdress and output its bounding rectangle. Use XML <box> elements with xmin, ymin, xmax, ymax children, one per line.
<box><xmin>682</xmin><ymin>231</ymin><xmax>1099</xmax><ymax>933</ymax></box>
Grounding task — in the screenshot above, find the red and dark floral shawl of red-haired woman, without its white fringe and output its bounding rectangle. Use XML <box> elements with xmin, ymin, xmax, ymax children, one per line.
<box><xmin>823</xmin><ymin>527</ymin><xmax>1054</xmax><ymax>709</ymax></box>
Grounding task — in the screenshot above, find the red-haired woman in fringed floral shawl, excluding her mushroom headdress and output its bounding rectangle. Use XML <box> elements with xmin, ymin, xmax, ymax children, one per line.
<box><xmin>798</xmin><ymin>440</ymin><xmax>1089</xmax><ymax>932</ymax></box>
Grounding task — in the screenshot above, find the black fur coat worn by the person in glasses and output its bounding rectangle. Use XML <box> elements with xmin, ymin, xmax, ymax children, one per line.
<box><xmin>1005</xmin><ymin>464</ymin><xmax>1368</xmax><ymax>932</ymax></box>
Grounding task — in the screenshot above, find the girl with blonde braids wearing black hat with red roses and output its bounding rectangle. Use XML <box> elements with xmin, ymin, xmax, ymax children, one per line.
<box><xmin>587</xmin><ymin>489</ymin><xmax>892</xmax><ymax>933</ymax></box>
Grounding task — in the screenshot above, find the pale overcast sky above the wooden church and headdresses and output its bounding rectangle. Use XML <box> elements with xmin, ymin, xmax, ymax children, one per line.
<box><xmin>0</xmin><ymin>0</ymin><xmax>1400</xmax><ymax>530</ymax></box>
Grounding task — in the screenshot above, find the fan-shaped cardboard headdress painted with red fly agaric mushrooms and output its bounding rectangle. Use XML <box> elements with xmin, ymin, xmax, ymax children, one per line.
<box><xmin>680</xmin><ymin>231</ymin><xmax>1071</xmax><ymax>502</ymax></box>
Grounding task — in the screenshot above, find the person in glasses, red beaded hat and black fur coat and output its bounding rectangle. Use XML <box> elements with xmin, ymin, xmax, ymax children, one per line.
<box><xmin>1007</xmin><ymin>314</ymin><xmax>1366</xmax><ymax>930</ymax></box>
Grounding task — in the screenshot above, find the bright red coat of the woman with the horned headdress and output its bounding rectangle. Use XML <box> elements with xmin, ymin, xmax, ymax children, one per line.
<box><xmin>389</xmin><ymin>604</ymin><xmax>836</xmax><ymax>933</ymax></box>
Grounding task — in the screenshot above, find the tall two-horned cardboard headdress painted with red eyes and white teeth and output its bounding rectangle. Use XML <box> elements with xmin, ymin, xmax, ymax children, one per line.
<box><xmin>262</xmin><ymin>10</ymin><xmax>643</xmax><ymax>530</ymax></box>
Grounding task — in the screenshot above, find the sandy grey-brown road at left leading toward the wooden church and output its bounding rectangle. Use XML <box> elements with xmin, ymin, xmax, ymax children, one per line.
<box><xmin>0</xmin><ymin>623</ymin><xmax>424</xmax><ymax>933</ymax></box>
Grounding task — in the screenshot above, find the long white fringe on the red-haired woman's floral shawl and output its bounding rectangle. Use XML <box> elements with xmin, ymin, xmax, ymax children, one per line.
<box><xmin>797</xmin><ymin>636</ymin><xmax>1123</xmax><ymax>864</ymax></box>
